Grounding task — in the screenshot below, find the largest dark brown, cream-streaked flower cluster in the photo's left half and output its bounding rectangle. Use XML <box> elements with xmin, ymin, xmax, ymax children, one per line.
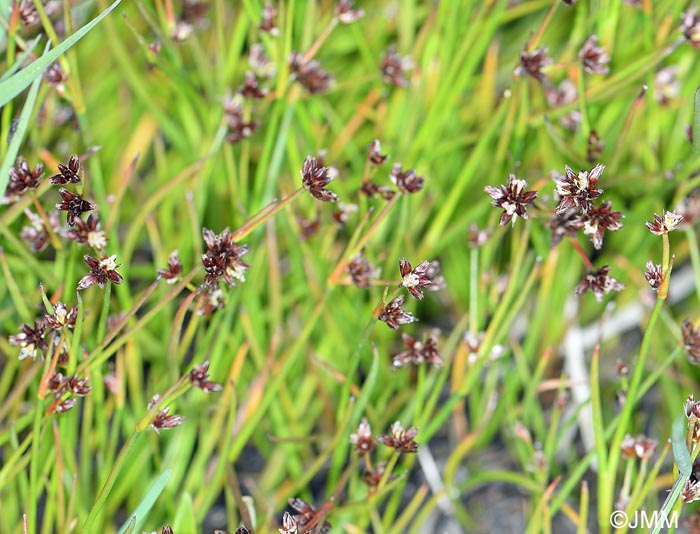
<box><xmin>202</xmin><ymin>227</ymin><xmax>249</xmax><ymax>288</ymax></box>
